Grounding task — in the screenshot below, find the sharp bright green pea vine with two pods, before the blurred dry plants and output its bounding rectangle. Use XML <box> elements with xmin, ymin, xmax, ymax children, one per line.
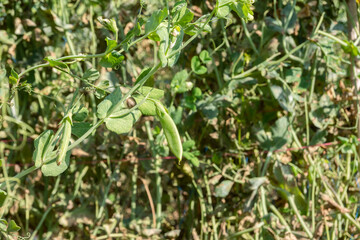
<box><xmin>0</xmin><ymin>0</ymin><xmax>253</xmax><ymax>236</ymax></box>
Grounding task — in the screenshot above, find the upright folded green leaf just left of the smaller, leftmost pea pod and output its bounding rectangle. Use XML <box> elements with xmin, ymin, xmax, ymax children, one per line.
<box><xmin>33</xmin><ymin>130</ymin><xmax>54</xmax><ymax>167</ymax></box>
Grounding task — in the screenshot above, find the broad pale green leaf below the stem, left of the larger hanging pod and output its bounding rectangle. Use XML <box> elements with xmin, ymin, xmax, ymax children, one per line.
<box><xmin>105</xmin><ymin>109</ymin><xmax>141</xmax><ymax>134</ymax></box>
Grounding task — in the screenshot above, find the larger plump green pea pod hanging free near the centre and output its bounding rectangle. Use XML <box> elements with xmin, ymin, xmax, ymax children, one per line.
<box><xmin>153</xmin><ymin>101</ymin><xmax>183</xmax><ymax>163</ymax></box>
